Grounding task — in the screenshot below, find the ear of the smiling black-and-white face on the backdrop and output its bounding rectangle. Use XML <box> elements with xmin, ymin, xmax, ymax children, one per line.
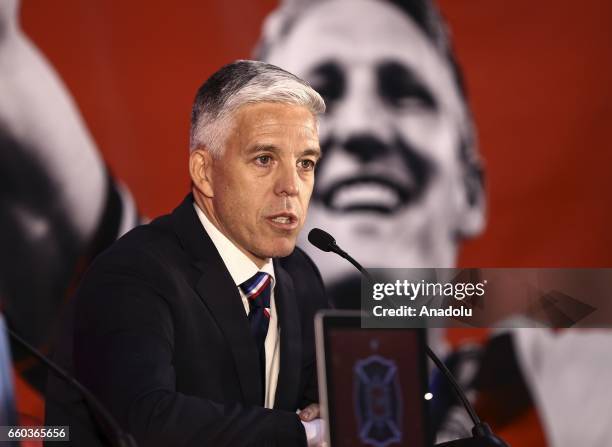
<box><xmin>456</xmin><ymin>144</ymin><xmax>487</xmax><ymax>238</ymax></box>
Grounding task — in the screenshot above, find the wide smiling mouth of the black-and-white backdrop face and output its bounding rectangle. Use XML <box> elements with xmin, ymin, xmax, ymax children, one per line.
<box><xmin>318</xmin><ymin>175</ymin><xmax>415</xmax><ymax>214</ymax></box>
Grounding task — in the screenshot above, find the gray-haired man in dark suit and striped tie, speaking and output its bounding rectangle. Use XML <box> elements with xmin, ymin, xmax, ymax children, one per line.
<box><xmin>47</xmin><ymin>61</ymin><xmax>327</xmax><ymax>447</ymax></box>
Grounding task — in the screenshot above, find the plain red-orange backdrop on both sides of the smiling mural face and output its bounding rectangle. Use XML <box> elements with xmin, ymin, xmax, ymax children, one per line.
<box><xmin>22</xmin><ymin>0</ymin><xmax>612</xmax><ymax>267</ymax></box>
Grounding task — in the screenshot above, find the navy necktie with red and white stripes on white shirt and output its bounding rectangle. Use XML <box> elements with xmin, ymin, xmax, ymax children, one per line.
<box><xmin>240</xmin><ymin>272</ymin><xmax>272</xmax><ymax>390</ymax></box>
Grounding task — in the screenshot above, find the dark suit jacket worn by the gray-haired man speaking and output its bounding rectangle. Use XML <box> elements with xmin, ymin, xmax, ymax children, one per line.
<box><xmin>46</xmin><ymin>195</ymin><xmax>327</xmax><ymax>447</ymax></box>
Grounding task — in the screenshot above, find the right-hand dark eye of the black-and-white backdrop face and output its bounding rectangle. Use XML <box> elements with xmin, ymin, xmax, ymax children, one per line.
<box><xmin>377</xmin><ymin>61</ymin><xmax>437</xmax><ymax>110</ymax></box>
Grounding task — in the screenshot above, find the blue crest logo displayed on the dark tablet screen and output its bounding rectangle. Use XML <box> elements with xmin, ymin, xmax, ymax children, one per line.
<box><xmin>353</xmin><ymin>355</ymin><xmax>402</xmax><ymax>447</ymax></box>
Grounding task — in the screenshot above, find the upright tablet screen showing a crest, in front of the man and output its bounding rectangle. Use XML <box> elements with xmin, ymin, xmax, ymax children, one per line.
<box><xmin>317</xmin><ymin>315</ymin><xmax>429</xmax><ymax>447</ymax></box>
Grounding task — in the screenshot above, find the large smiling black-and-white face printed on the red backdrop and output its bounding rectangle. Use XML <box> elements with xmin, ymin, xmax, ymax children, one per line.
<box><xmin>266</xmin><ymin>0</ymin><xmax>483</xmax><ymax>288</ymax></box>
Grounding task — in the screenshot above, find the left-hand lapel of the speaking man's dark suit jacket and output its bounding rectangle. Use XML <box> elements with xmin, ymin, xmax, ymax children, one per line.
<box><xmin>172</xmin><ymin>194</ymin><xmax>262</xmax><ymax>405</ymax></box>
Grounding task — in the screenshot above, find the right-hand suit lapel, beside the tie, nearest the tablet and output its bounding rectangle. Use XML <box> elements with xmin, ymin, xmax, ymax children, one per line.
<box><xmin>274</xmin><ymin>260</ymin><xmax>302</xmax><ymax>411</ymax></box>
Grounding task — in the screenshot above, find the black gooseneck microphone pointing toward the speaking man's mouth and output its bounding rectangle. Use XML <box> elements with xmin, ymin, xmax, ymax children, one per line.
<box><xmin>308</xmin><ymin>228</ymin><xmax>509</xmax><ymax>447</ymax></box>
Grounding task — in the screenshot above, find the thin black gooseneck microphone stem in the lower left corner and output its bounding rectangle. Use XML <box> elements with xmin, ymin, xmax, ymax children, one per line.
<box><xmin>6</xmin><ymin>326</ymin><xmax>138</xmax><ymax>447</ymax></box>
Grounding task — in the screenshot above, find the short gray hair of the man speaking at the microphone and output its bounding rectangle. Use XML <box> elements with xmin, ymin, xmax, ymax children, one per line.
<box><xmin>189</xmin><ymin>60</ymin><xmax>325</xmax><ymax>157</ymax></box>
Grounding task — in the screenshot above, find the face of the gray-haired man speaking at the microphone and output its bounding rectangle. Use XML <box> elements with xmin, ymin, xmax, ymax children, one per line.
<box><xmin>196</xmin><ymin>103</ymin><xmax>320</xmax><ymax>265</ymax></box>
